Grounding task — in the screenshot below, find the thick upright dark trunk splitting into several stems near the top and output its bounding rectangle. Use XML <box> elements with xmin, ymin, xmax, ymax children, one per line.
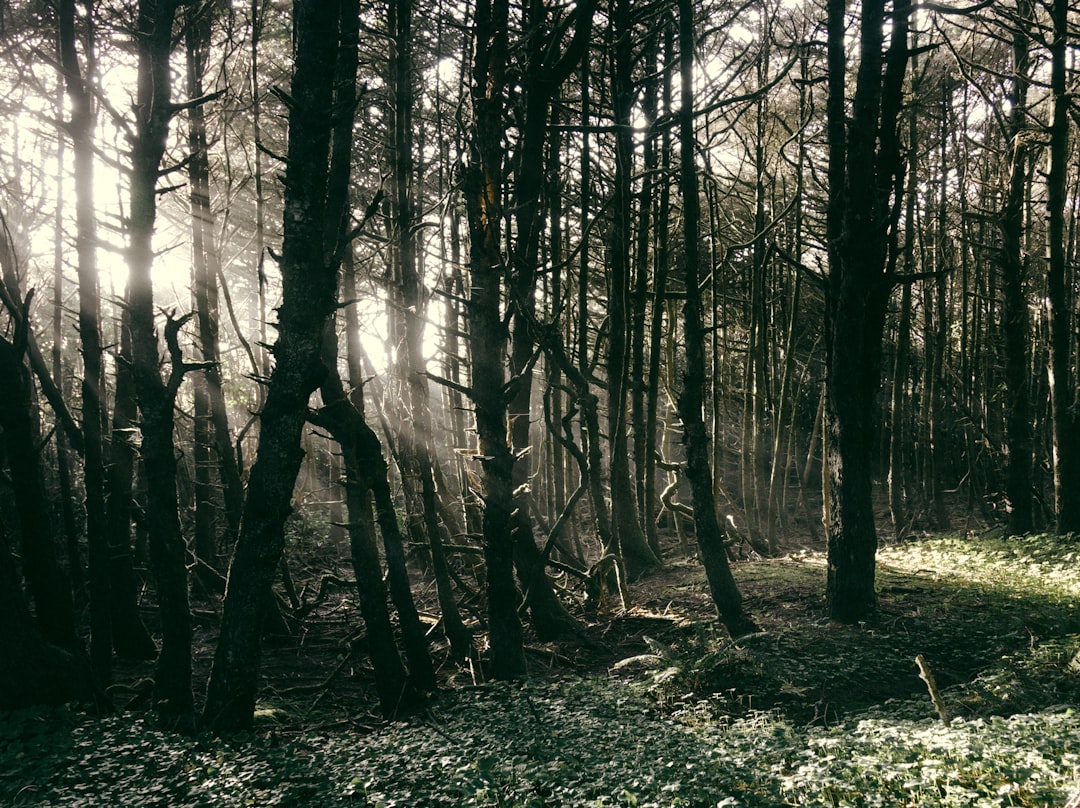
<box><xmin>823</xmin><ymin>0</ymin><xmax>910</xmax><ymax>623</ymax></box>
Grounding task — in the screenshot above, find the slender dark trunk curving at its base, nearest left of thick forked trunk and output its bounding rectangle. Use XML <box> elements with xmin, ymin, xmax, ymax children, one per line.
<box><xmin>678</xmin><ymin>0</ymin><xmax>757</xmax><ymax>637</ymax></box>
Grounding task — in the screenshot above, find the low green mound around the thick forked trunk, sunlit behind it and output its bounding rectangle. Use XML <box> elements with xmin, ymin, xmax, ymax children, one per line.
<box><xmin>617</xmin><ymin>536</ymin><xmax>1080</xmax><ymax>724</ymax></box>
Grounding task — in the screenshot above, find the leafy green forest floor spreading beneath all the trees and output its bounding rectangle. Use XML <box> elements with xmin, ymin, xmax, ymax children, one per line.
<box><xmin>0</xmin><ymin>535</ymin><xmax>1080</xmax><ymax>807</ymax></box>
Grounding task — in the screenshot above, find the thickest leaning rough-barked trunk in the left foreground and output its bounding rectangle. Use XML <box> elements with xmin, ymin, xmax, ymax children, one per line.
<box><xmin>203</xmin><ymin>0</ymin><xmax>340</xmax><ymax>731</ymax></box>
